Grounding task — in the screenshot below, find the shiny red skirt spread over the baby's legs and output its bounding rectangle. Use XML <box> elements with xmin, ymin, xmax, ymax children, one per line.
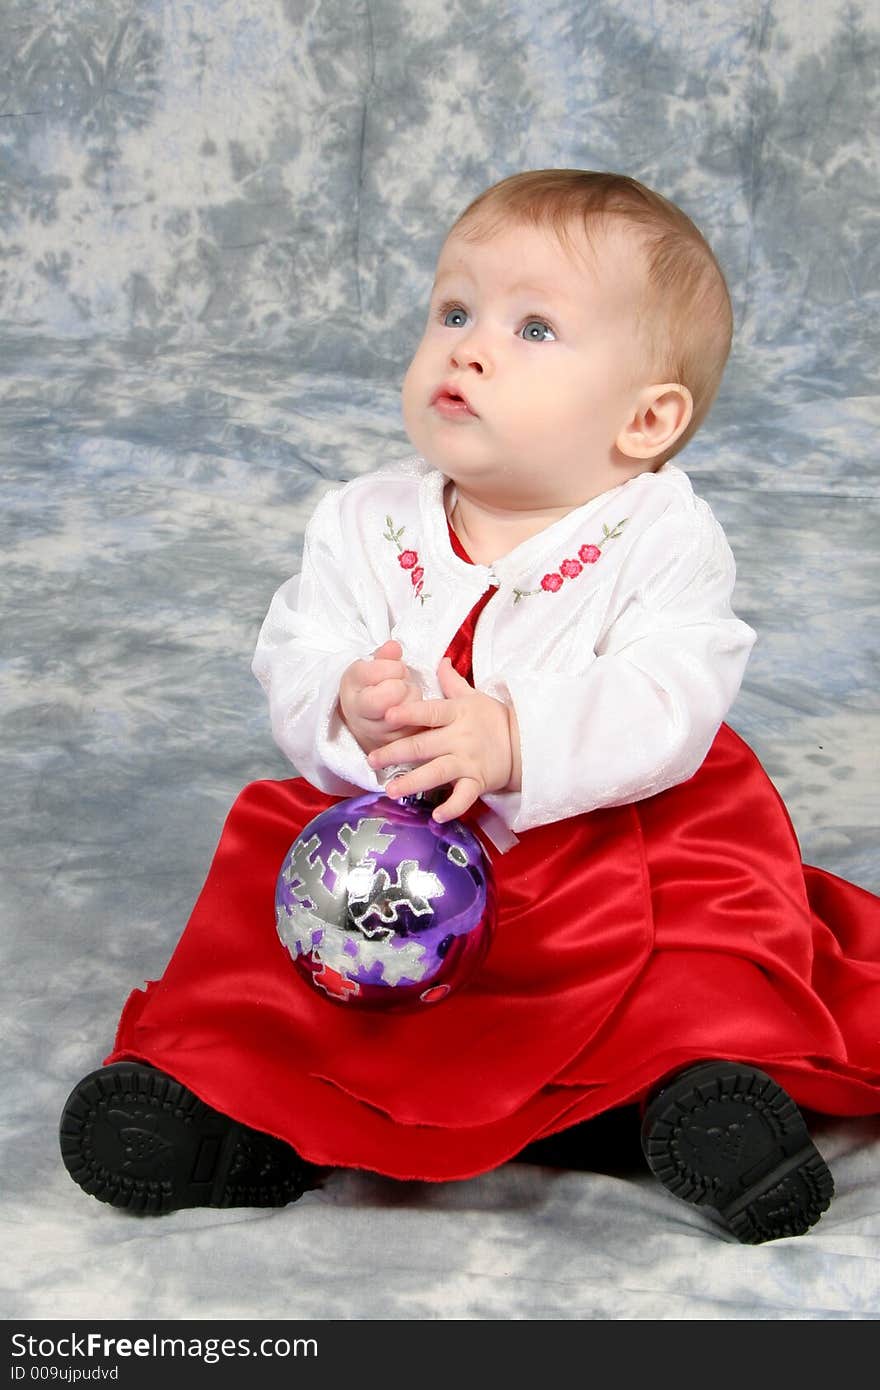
<box><xmin>107</xmin><ymin>726</ymin><xmax>880</xmax><ymax>1180</ymax></box>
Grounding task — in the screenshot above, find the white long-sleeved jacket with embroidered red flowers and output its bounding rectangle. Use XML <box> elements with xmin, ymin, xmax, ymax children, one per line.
<box><xmin>253</xmin><ymin>459</ymin><xmax>755</xmax><ymax>831</ymax></box>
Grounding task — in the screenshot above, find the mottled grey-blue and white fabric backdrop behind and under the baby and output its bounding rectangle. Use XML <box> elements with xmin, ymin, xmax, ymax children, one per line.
<box><xmin>0</xmin><ymin>0</ymin><xmax>880</xmax><ymax>1319</ymax></box>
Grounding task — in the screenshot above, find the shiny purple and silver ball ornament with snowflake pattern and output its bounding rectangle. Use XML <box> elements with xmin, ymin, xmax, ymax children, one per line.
<box><xmin>275</xmin><ymin>792</ymin><xmax>495</xmax><ymax>1009</ymax></box>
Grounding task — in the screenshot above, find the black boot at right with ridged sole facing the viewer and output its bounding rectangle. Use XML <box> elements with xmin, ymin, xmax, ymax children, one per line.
<box><xmin>642</xmin><ymin>1062</ymin><xmax>834</xmax><ymax>1245</ymax></box>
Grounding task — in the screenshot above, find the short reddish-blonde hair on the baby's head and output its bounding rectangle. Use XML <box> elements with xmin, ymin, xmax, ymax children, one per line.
<box><xmin>452</xmin><ymin>170</ymin><xmax>733</xmax><ymax>466</ymax></box>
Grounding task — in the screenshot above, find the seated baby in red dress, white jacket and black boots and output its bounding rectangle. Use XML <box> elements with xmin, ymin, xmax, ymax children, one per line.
<box><xmin>61</xmin><ymin>170</ymin><xmax>880</xmax><ymax>1243</ymax></box>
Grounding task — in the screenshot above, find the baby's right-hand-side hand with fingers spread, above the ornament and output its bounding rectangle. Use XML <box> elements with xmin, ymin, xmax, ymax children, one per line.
<box><xmin>368</xmin><ymin>656</ymin><xmax>521</xmax><ymax>821</ymax></box>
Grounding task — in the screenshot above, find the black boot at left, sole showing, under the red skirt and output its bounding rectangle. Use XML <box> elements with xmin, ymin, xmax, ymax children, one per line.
<box><xmin>60</xmin><ymin>1062</ymin><xmax>324</xmax><ymax>1215</ymax></box>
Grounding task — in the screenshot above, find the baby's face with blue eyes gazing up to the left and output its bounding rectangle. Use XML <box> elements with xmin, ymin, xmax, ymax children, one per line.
<box><xmin>403</xmin><ymin>225</ymin><xmax>649</xmax><ymax>509</ymax></box>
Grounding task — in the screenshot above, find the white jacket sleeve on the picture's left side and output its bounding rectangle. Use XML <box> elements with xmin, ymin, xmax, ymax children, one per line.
<box><xmin>252</xmin><ymin>489</ymin><xmax>388</xmax><ymax>796</ymax></box>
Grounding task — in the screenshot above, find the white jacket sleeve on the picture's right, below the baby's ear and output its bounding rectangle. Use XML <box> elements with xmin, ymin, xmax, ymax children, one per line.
<box><xmin>484</xmin><ymin>502</ymin><xmax>755</xmax><ymax>831</ymax></box>
